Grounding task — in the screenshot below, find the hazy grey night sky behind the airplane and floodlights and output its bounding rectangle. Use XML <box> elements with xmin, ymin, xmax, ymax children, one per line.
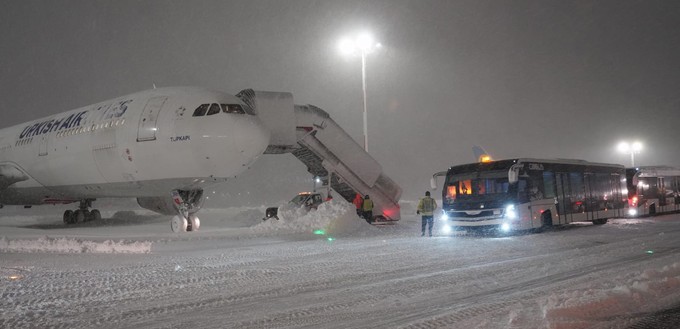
<box><xmin>0</xmin><ymin>0</ymin><xmax>680</xmax><ymax>200</ymax></box>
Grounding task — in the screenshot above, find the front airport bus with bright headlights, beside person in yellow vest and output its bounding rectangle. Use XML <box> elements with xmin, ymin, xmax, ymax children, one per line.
<box><xmin>431</xmin><ymin>158</ymin><xmax>627</xmax><ymax>232</ymax></box>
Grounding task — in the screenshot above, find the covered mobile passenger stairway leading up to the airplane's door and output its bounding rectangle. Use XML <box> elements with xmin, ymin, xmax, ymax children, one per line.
<box><xmin>236</xmin><ymin>89</ymin><xmax>401</xmax><ymax>224</ymax></box>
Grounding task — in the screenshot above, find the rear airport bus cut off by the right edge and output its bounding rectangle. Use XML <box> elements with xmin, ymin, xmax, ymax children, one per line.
<box><xmin>626</xmin><ymin>166</ymin><xmax>680</xmax><ymax>217</ymax></box>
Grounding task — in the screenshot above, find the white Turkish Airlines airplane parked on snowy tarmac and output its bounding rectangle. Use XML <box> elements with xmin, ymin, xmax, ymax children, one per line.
<box><xmin>0</xmin><ymin>87</ymin><xmax>270</xmax><ymax>232</ymax></box>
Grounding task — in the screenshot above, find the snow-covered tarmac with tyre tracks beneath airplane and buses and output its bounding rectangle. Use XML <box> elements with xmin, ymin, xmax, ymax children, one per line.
<box><xmin>0</xmin><ymin>201</ymin><xmax>680</xmax><ymax>328</ymax></box>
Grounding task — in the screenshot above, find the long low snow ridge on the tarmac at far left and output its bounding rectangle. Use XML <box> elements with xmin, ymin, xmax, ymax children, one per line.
<box><xmin>0</xmin><ymin>236</ymin><xmax>151</xmax><ymax>254</ymax></box>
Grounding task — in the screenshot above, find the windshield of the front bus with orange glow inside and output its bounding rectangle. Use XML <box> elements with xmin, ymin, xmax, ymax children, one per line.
<box><xmin>444</xmin><ymin>171</ymin><xmax>510</xmax><ymax>203</ymax></box>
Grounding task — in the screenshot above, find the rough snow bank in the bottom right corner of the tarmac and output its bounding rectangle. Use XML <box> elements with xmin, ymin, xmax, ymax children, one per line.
<box><xmin>539</xmin><ymin>263</ymin><xmax>680</xmax><ymax>327</ymax></box>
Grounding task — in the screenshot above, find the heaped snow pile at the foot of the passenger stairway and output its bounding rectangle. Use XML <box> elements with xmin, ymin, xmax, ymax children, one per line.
<box><xmin>251</xmin><ymin>200</ymin><xmax>375</xmax><ymax>236</ymax></box>
